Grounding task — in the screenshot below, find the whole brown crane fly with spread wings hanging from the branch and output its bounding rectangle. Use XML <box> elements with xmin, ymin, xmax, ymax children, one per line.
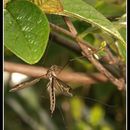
<box><xmin>10</xmin><ymin>65</ymin><xmax>72</xmax><ymax>114</ymax></box>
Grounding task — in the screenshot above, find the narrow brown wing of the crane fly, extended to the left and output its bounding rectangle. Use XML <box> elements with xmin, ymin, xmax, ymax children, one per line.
<box><xmin>10</xmin><ymin>77</ymin><xmax>41</xmax><ymax>92</ymax></box>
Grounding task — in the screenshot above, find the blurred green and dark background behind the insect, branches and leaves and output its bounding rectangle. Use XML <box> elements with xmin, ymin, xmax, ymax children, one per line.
<box><xmin>4</xmin><ymin>0</ymin><xmax>126</xmax><ymax>130</ymax></box>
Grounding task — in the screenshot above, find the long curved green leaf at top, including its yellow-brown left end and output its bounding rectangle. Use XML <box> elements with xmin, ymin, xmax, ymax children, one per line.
<box><xmin>35</xmin><ymin>0</ymin><xmax>126</xmax><ymax>47</ymax></box>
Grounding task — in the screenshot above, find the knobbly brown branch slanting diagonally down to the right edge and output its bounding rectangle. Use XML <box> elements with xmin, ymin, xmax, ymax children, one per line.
<box><xmin>64</xmin><ymin>17</ymin><xmax>125</xmax><ymax>90</ymax></box>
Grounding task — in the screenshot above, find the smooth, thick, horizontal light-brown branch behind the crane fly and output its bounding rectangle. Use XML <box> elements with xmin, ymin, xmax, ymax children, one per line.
<box><xmin>4</xmin><ymin>61</ymin><xmax>108</xmax><ymax>85</ymax></box>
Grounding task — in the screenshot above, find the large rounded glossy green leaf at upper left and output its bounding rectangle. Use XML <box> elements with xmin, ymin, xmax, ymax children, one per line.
<box><xmin>4</xmin><ymin>1</ymin><xmax>50</xmax><ymax>64</ymax></box>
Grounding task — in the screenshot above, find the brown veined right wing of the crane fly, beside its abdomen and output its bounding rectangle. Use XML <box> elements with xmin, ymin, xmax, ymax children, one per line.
<box><xmin>55</xmin><ymin>77</ymin><xmax>73</xmax><ymax>96</ymax></box>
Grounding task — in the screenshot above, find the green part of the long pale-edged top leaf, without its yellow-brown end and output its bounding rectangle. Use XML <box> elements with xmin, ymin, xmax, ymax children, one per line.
<box><xmin>61</xmin><ymin>0</ymin><xmax>126</xmax><ymax>46</ymax></box>
